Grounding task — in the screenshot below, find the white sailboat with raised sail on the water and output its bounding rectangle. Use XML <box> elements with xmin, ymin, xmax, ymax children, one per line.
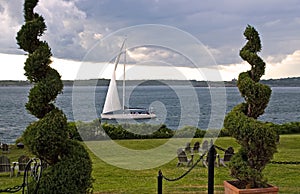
<box><xmin>101</xmin><ymin>39</ymin><xmax>156</xmax><ymax>119</ymax></box>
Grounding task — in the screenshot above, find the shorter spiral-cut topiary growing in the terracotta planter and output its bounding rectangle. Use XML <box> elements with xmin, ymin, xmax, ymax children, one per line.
<box><xmin>224</xmin><ymin>25</ymin><xmax>279</xmax><ymax>188</ymax></box>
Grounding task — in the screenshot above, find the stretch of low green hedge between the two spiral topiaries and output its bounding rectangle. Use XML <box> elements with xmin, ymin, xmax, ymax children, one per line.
<box><xmin>74</xmin><ymin>120</ymin><xmax>228</xmax><ymax>141</ymax></box>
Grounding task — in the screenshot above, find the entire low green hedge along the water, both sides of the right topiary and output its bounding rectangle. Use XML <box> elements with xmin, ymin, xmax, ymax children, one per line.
<box><xmin>69</xmin><ymin>120</ymin><xmax>300</xmax><ymax>141</ymax></box>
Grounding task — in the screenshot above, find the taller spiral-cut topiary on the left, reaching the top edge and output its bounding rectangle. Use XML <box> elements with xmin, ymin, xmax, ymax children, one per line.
<box><xmin>16</xmin><ymin>0</ymin><xmax>92</xmax><ymax>194</ymax></box>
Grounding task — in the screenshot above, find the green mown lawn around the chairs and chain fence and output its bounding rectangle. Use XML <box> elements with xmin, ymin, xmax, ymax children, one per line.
<box><xmin>0</xmin><ymin>135</ymin><xmax>300</xmax><ymax>194</ymax></box>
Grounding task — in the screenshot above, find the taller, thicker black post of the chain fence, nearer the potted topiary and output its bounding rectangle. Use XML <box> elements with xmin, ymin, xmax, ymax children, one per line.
<box><xmin>208</xmin><ymin>141</ymin><xmax>216</xmax><ymax>194</ymax></box>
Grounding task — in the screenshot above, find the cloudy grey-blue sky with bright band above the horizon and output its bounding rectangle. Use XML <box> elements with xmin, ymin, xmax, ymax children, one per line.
<box><xmin>0</xmin><ymin>0</ymin><xmax>300</xmax><ymax>80</ymax></box>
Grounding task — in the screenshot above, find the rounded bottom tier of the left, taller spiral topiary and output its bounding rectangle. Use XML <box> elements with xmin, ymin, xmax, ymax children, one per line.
<box><xmin>38</xmin><ymin>140</ymin><xmax>92</xmax><ymax>194</ymax></box>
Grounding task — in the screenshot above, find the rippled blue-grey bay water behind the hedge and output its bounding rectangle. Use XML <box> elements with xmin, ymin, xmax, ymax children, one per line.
<box><xmin>0</xmin><ymin>85</ymin><xmax>300</xmax><ymax>143</ymax></box>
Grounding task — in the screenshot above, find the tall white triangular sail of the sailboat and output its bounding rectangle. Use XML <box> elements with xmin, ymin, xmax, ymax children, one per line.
<box><xmin>102</xmin><ymin>40</ymin><xmax>125</xmax><ymax>114</ymax></box>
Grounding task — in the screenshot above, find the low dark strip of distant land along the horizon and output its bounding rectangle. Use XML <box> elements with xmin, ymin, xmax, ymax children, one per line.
<box><xmin>0</xmin><ymin>77</ymin><xmax>300</xmax><ymax>87</ymax></box>
